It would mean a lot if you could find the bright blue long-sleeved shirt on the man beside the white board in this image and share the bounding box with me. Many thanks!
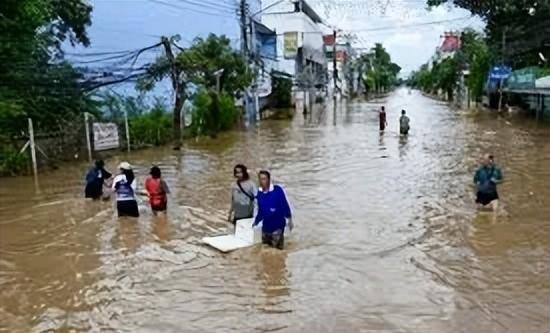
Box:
[254,185,292,234]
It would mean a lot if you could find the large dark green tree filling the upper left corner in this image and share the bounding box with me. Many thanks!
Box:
[0,0,94,137]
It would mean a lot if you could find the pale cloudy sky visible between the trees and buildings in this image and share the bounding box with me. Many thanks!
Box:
[77,0,483,80]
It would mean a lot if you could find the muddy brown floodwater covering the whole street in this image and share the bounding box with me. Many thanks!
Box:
[0,90,550,333]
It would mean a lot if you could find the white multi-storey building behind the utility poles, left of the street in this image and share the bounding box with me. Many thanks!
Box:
[262,0,327,83]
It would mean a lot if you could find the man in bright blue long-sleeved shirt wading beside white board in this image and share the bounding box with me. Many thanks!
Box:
[254,170,294,250]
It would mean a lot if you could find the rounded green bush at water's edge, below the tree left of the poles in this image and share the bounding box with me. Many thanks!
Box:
[191,89,239,137]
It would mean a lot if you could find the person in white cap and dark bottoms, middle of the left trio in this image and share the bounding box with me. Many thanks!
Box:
[113,162,139,217]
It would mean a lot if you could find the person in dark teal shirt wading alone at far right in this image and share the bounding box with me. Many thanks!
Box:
[474,155,502,211]
